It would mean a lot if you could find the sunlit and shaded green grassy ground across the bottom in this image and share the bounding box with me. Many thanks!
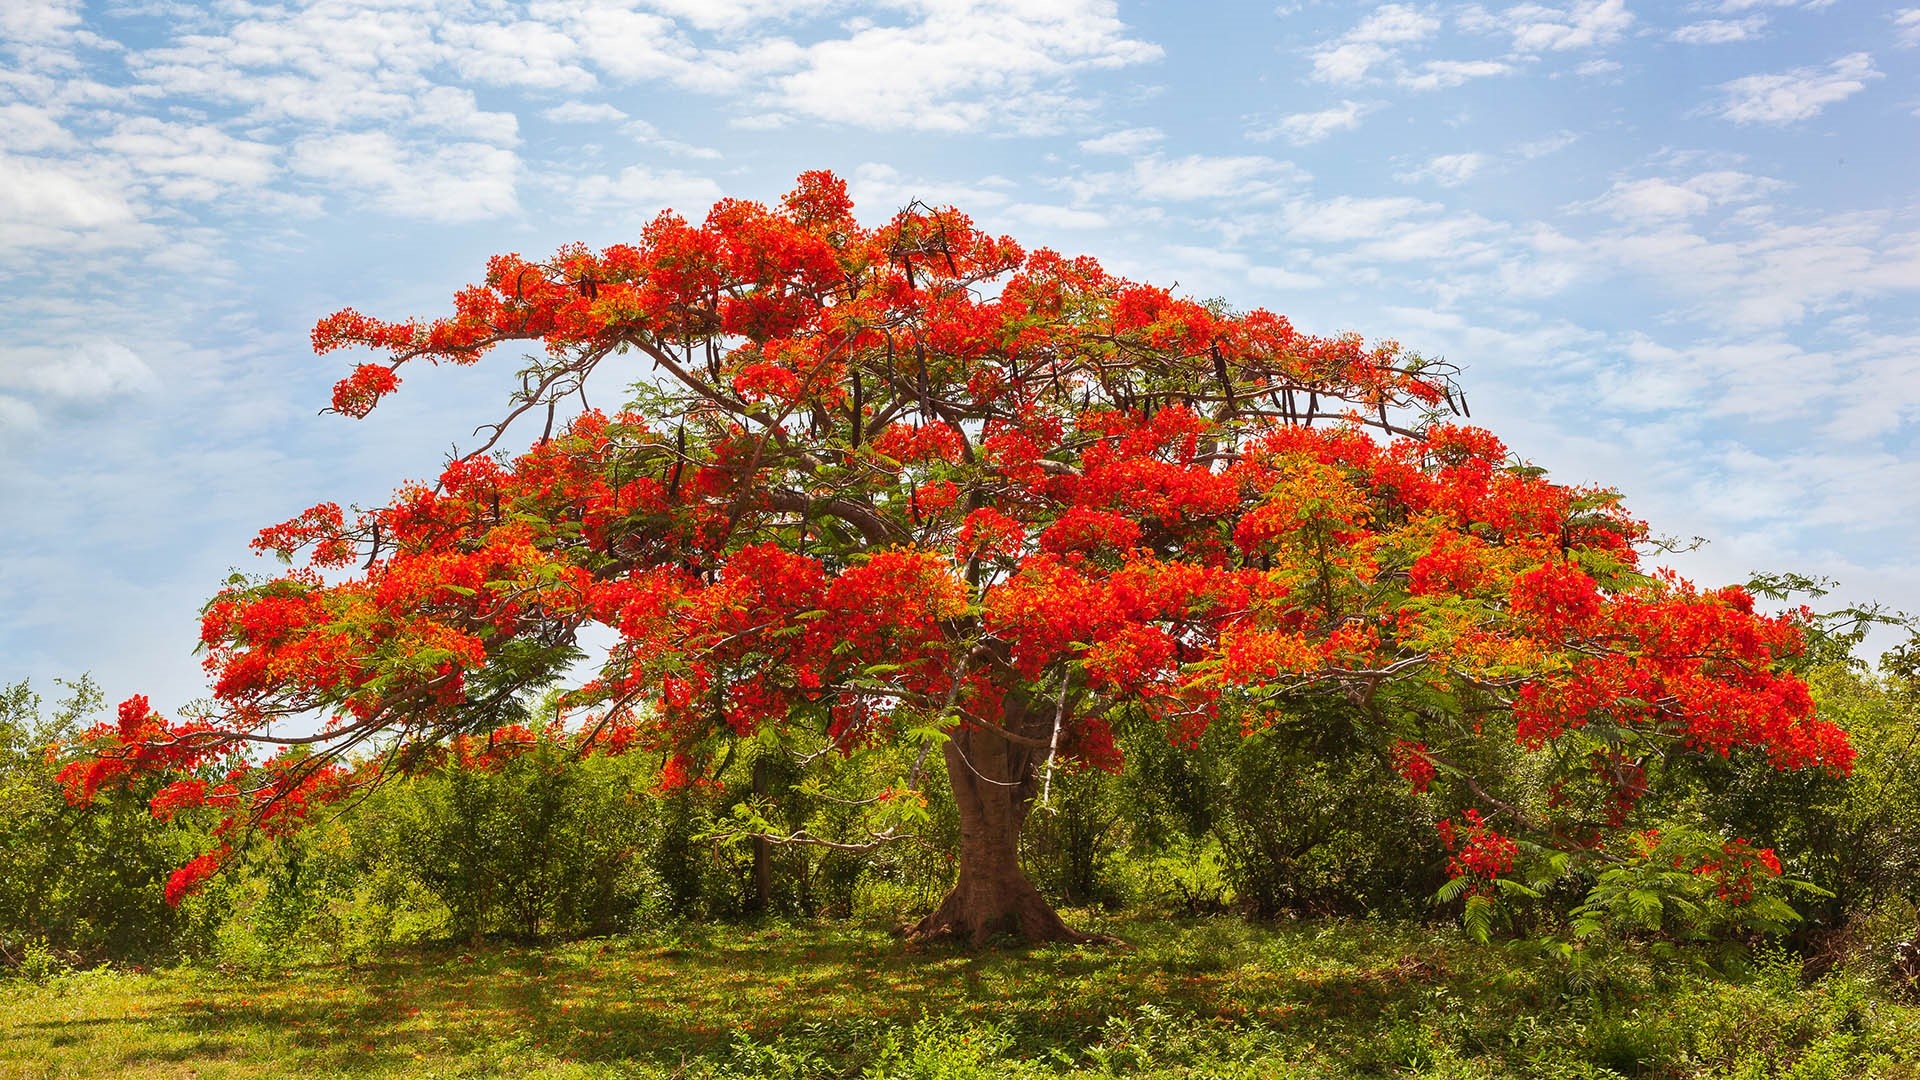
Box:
[0,913,1920,1080]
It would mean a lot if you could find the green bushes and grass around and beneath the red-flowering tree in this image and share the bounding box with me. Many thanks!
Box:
[11,622,1920,1080]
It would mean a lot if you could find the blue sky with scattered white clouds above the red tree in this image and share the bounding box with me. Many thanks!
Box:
[0,0,1920,707]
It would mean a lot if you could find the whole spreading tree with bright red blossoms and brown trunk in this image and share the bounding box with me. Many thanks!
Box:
[69,173,1849,940]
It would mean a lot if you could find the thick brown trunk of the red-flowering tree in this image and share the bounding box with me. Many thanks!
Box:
[908,701,1092,945]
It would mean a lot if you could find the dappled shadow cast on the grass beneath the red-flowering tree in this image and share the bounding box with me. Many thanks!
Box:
[15,926,1505,1076]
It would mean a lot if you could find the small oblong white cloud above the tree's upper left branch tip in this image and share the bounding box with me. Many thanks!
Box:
[288,131,520,223]
